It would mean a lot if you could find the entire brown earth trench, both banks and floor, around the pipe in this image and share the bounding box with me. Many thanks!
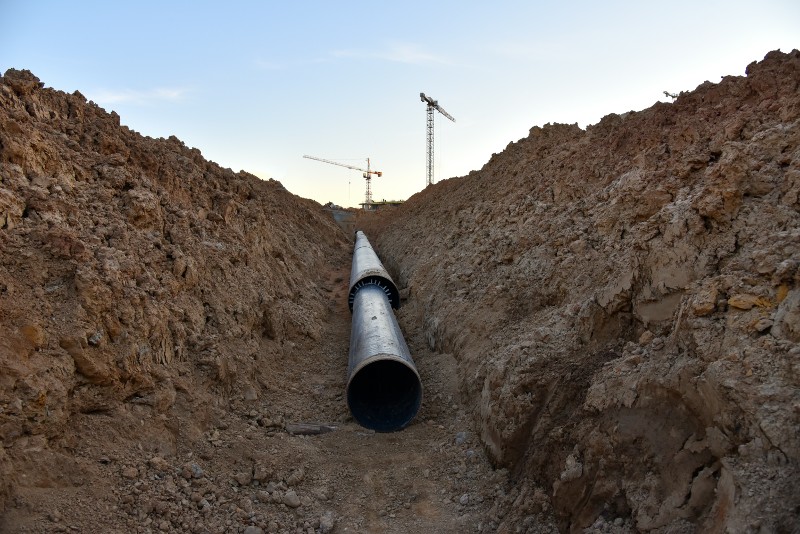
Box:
[0,51,800,534]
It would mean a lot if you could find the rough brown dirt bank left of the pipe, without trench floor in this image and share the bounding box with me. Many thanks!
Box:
[0,69,360,530]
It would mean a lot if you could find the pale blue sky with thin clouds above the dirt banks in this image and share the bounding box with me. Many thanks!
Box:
[0,0,800,206]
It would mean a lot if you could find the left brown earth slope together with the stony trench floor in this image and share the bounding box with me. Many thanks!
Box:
[0,69,509,534]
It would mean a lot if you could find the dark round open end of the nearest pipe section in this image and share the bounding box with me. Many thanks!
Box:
[347,358,422,432]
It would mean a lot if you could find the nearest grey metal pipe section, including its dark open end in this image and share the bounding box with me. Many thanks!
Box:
[347,232,422,432]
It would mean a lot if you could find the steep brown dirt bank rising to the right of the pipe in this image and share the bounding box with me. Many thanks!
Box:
[360,51,800,532]
